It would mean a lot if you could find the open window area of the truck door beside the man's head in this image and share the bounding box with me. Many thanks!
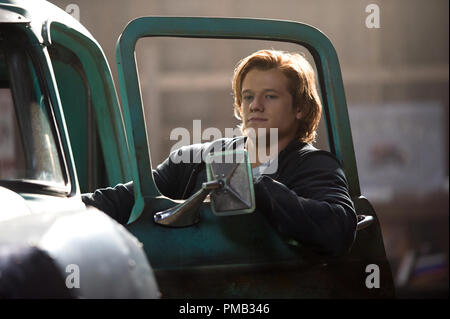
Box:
[136,37,329,169]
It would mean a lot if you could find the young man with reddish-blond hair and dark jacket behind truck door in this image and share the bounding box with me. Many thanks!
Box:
[83,50,357,256]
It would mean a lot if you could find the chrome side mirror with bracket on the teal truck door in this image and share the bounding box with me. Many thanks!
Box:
[153,150,255,227]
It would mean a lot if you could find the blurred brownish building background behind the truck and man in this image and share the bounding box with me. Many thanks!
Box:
[51,0,449,298]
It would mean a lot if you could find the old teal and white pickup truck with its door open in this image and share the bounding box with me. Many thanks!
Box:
[0,0,394,298]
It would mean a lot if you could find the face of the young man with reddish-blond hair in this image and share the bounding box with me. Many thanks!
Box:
[241,68,301,141]
